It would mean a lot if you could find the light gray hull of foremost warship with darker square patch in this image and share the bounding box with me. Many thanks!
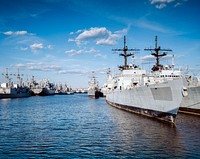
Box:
[106,78,183,123]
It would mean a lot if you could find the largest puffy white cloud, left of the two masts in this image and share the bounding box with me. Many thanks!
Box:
[68,27,127,45]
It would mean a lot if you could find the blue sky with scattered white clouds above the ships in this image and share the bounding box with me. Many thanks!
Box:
[0,0,200,88]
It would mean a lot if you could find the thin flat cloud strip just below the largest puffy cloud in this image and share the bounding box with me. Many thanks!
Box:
[65,48,99,56]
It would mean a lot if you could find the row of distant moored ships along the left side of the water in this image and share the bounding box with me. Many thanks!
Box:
[0,69,73,99]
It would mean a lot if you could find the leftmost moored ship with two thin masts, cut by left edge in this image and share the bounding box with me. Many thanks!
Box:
[0,69,31,99]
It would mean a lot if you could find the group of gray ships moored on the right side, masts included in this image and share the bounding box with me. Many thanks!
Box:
[88,36,200,124]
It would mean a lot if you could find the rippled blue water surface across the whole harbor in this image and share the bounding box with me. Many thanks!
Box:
[0,94,200,159]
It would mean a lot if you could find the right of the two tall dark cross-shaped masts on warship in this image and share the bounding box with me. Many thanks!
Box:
[144,36,172,71]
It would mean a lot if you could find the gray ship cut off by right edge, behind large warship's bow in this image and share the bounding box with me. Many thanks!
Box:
[179,76,200,115]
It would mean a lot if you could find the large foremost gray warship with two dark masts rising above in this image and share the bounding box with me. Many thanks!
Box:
[106,36,187,124]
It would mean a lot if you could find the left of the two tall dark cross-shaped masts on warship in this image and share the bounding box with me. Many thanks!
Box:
[112,36,140,70]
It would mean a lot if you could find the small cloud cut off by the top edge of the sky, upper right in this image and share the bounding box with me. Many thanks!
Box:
[150,0,186,9]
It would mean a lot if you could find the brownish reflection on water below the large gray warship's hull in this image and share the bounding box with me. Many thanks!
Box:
[105,104,185,158]
